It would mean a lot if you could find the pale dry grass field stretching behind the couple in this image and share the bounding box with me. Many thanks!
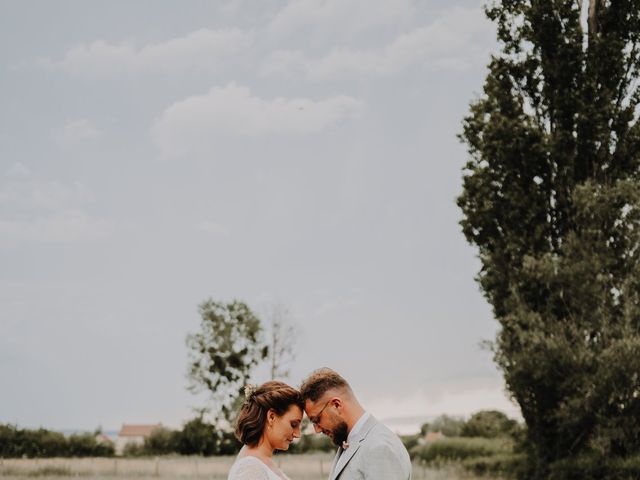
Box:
[0,454,500,480]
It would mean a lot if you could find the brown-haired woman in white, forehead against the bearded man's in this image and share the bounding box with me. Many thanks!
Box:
[228,381,304,480]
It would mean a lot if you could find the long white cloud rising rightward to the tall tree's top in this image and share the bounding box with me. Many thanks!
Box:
[261,7,493,80]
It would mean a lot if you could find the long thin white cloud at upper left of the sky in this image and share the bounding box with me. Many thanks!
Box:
[39,28,253,76]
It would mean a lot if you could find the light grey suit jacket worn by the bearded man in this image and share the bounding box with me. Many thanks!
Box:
[329,416,411,480]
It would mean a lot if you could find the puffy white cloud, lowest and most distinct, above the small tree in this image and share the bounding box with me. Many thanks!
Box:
[152,83,362,155]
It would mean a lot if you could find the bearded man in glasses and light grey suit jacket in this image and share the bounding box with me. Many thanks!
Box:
[300,368,411,480]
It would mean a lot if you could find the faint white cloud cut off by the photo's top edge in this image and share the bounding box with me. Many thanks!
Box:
[268,0,413,39]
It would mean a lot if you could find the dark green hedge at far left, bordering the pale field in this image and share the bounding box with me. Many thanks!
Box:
[0,425,114,458]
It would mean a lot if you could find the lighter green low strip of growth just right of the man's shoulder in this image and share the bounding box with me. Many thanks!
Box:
[411,437,513,465]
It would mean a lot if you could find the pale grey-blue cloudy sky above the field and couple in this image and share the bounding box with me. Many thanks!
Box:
[0,0,518,429]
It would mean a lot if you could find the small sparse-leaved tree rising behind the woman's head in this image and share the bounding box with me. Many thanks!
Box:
[187,300,268,421]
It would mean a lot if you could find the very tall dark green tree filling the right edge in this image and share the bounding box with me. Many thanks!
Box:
[458,0,640,478]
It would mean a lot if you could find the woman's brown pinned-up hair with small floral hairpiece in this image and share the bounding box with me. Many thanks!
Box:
[235,381,304,447]
